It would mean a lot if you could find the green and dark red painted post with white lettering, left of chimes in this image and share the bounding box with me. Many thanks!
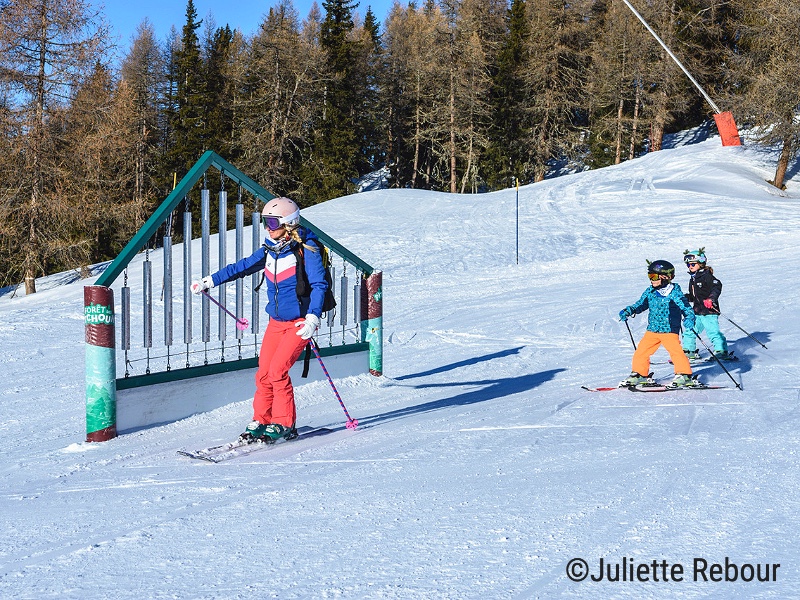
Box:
[83,285,117,442]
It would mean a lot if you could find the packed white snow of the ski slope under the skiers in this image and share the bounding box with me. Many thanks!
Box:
[0,132,800,600]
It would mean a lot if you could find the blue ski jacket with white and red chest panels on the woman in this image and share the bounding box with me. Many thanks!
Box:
[211,227,328,321]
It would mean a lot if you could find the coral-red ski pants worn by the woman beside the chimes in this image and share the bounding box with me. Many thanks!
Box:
[253,319,308,427]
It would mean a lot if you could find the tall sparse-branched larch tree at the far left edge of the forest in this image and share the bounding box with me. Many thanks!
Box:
[0,0,107,294]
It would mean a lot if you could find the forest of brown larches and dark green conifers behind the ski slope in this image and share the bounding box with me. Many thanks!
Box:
[0,0,800,293]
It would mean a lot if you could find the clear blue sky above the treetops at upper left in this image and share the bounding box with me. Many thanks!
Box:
[97,0,396,49]
